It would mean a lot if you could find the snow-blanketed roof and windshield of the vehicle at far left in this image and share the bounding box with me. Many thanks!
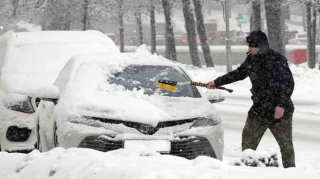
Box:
[0,30,120,96]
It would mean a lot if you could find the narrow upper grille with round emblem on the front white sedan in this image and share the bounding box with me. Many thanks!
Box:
[86,117,198,135]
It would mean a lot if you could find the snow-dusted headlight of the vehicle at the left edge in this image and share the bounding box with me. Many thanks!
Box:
[3,93,35,113]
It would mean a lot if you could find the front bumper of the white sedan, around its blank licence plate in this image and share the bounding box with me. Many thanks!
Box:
[58,119,223,160]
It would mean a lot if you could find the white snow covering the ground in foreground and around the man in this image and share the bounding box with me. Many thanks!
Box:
[0,46,320,179]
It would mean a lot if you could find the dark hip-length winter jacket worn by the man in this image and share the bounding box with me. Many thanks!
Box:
[214,47,294,122]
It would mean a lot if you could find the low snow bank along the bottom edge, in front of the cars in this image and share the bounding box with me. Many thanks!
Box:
[0,148,319,179]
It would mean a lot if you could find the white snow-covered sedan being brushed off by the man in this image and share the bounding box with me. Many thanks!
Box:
[36,47,224,160]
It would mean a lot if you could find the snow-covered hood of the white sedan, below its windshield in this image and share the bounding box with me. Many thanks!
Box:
[59,91,217,126]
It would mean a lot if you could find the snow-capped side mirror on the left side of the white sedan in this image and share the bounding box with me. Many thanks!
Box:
[36,85,60,104]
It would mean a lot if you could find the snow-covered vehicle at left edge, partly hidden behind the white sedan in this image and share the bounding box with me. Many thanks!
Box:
[0,31,120,152]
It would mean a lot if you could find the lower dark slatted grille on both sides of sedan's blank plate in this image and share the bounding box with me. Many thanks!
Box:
[78,136,216,159]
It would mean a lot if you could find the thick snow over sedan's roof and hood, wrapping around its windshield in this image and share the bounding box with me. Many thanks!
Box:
[55,46,217,126]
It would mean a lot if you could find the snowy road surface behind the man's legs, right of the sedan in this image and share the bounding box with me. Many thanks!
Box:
[219,92,320,169]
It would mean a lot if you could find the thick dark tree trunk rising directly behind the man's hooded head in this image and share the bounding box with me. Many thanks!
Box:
[265,0,285,55]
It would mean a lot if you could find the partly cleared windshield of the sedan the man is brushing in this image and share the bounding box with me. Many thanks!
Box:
[109,65,200,98]
